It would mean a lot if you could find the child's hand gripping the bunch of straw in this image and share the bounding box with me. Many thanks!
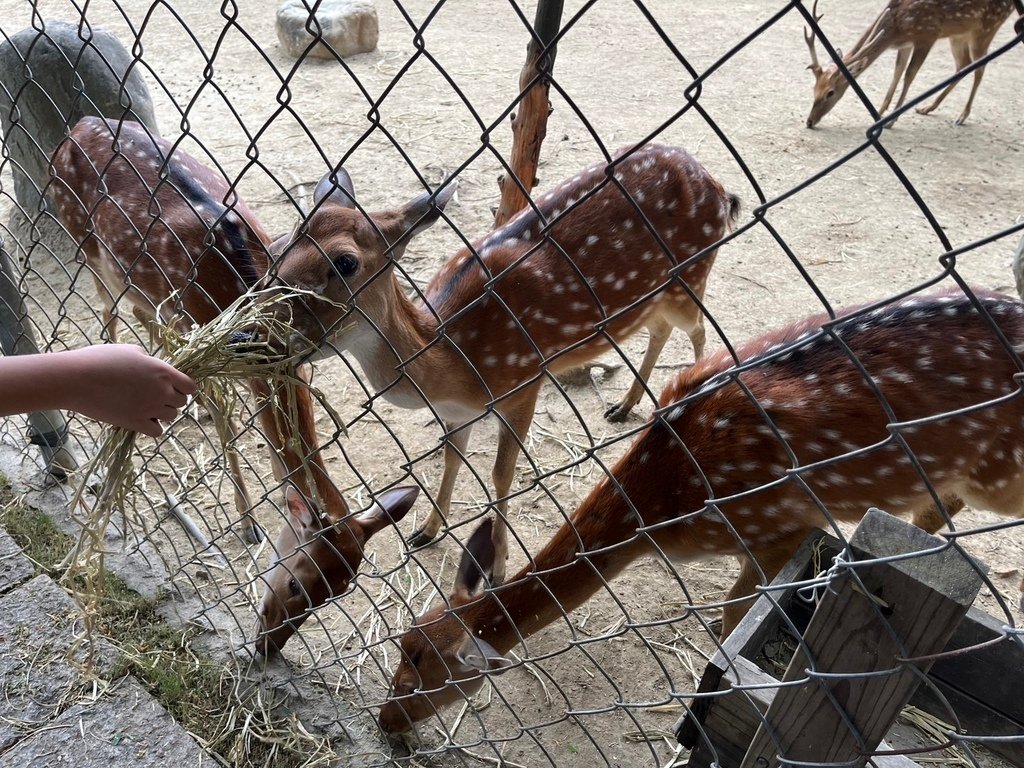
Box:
[59,344,196,437]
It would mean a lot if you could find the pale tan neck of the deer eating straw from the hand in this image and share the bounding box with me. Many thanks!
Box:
[346,278,461,408]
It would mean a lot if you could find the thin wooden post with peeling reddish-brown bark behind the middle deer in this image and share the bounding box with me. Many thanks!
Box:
[495,0,563,227]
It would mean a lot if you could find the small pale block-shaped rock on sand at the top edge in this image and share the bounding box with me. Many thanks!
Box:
[278,0,380,58]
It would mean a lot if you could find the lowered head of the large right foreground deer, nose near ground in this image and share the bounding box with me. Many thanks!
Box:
[379,519,512,733]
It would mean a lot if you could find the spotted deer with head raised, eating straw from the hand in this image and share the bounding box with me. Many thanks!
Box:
[256,144,738,582]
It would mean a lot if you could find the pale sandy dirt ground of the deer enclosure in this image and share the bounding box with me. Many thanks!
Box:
[0,0,1024,766]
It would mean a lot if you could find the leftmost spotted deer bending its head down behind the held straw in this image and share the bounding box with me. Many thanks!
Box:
[52,118,417,650]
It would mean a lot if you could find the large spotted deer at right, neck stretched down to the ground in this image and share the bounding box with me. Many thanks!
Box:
[380,292,1024,732]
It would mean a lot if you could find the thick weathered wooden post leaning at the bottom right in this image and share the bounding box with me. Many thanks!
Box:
[741,510,981,768]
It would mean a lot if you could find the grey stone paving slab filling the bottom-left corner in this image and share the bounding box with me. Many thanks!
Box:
[0,678,209,768]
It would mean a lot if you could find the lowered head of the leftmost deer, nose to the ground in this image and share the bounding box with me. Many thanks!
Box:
[256,485,420,654]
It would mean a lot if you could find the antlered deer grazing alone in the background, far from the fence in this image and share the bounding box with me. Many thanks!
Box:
[804,0,1013,128]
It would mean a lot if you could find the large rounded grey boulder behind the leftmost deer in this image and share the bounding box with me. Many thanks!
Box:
[0,20,157,218]
